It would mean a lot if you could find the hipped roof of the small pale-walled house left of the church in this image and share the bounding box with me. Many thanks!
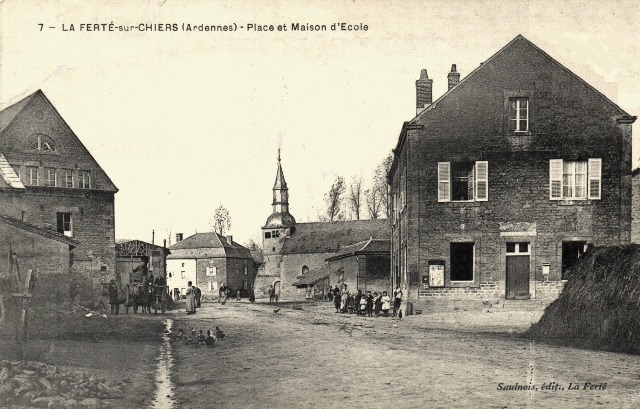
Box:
[167,232,253,259]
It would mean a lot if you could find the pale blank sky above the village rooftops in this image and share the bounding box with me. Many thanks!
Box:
[0,0,640,244]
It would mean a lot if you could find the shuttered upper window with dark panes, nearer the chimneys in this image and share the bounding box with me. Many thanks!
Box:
[438,161,489,202]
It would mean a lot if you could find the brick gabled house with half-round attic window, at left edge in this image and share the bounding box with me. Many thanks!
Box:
[0,90,118,299]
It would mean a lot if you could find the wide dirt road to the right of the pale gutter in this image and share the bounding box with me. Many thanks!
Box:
[173,303,640,408]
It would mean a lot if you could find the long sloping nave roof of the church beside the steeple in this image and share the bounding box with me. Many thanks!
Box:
[280,219,391,254]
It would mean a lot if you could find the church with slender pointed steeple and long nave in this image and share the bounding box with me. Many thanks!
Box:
[255,153,389,300]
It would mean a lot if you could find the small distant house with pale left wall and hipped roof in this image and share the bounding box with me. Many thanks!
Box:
[167,232,256,297]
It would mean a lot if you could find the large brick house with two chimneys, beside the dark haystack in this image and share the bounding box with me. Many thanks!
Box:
[389,35,636,305]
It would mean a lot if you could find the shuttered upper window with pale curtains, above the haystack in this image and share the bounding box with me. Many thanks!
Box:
[549,159,602,200]
